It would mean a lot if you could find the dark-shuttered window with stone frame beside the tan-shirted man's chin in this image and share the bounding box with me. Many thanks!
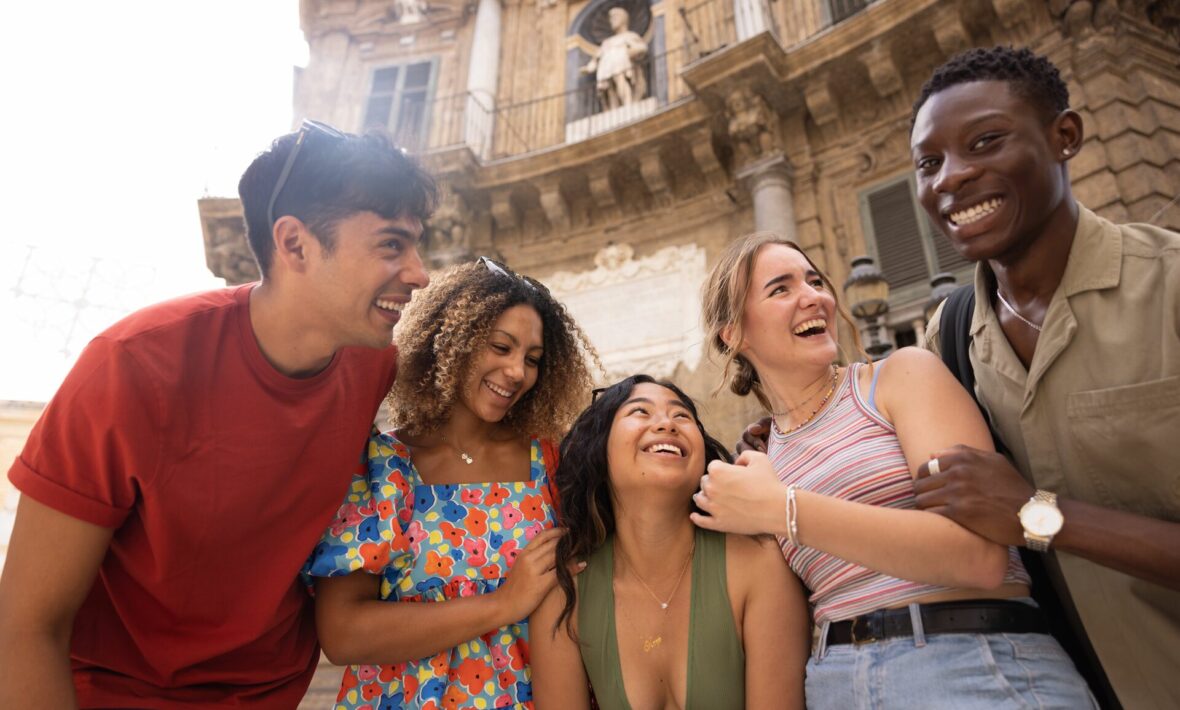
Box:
[860,175,968,294]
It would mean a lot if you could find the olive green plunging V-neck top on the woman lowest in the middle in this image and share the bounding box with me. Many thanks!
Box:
[577,528,746,710]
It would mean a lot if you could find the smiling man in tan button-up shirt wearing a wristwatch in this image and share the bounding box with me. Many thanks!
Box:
[911,47,1180,709]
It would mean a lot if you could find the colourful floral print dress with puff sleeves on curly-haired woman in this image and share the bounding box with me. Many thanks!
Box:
[307,430,556,710]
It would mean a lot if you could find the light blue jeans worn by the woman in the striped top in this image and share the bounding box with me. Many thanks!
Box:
[806,603,1099,710]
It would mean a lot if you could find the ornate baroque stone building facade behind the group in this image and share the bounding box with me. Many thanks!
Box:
[201,0,1180,440]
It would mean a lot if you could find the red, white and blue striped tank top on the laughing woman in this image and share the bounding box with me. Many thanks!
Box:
[768,362,1029,624]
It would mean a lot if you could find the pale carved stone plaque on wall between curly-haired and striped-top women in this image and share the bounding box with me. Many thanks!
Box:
[543,244,706,379]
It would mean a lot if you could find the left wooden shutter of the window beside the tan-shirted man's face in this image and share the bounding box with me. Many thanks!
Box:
[866,180,930,289]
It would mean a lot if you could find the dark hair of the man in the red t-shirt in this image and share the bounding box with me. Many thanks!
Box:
[237,131,438,277]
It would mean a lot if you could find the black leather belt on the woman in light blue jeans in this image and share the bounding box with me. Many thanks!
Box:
[827,600,1049,646]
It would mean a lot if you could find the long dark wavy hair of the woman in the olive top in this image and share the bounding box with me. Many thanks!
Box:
[553,375,732,638]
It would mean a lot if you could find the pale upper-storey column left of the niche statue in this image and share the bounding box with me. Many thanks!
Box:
[464,0,500,158]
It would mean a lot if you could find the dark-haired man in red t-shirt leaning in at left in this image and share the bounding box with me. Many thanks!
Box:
[0,121,437,708]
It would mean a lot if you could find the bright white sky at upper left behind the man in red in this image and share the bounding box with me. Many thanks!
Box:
[0,0,307,401]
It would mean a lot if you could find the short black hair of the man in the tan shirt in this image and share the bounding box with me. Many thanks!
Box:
[910,46,1069,126]
